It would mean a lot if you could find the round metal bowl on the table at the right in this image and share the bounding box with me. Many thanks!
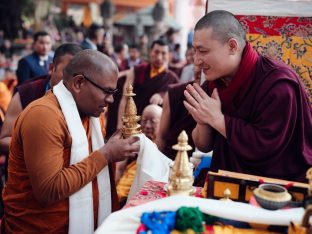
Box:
[253,184,291,210]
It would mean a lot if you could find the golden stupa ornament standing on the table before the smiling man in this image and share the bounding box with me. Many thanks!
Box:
[168,131,194,196]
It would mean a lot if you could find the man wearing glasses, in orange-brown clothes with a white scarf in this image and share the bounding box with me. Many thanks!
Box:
[4,50,139,233]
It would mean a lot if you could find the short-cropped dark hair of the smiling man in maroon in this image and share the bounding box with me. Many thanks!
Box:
[195,10,246,48]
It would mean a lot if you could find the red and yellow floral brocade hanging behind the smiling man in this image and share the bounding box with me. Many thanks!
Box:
[236,15,312,102]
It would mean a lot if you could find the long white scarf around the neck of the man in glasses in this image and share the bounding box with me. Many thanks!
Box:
[53,81,112,234]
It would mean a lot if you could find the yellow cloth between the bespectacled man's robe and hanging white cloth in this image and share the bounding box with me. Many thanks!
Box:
[117,161,137,201]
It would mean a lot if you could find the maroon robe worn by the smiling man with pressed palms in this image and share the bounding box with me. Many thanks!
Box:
[210,56,312,182]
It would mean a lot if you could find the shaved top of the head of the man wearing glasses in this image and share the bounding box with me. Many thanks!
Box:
[63,49,118,81]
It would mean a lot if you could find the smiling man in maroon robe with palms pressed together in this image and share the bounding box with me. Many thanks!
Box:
[184,11,312,182]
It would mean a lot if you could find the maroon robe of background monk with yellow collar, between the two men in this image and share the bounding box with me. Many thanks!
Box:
[133,64,178,115]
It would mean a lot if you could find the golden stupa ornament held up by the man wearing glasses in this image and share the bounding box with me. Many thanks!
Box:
[121,84,141,138]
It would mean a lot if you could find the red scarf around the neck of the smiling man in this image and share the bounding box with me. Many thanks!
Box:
[209,42,259,113]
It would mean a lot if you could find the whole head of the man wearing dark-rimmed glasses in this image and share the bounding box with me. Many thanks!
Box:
[63,50,118,117]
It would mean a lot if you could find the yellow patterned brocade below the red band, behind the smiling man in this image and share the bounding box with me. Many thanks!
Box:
[247,34,312,102]
